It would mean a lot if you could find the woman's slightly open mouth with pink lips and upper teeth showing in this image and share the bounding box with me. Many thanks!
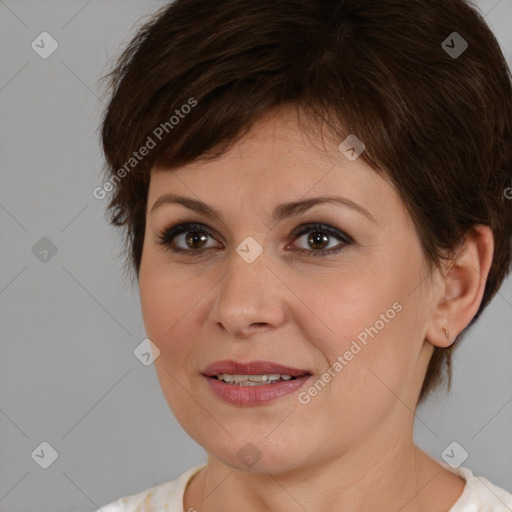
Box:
[201,360,312,405]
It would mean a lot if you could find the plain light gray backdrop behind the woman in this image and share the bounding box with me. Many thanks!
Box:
[0,0,512,512]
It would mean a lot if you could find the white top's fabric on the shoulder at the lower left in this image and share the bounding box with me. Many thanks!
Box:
[96,464,205,512]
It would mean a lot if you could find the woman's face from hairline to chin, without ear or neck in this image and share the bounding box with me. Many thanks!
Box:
[139,108,433,472]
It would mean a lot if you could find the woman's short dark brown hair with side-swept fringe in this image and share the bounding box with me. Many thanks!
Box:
[101,0,512,402]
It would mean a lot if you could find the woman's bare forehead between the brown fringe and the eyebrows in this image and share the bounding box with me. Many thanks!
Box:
[148,107,397,222]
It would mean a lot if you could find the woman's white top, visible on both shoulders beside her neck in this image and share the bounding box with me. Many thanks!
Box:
[96,461,512,512]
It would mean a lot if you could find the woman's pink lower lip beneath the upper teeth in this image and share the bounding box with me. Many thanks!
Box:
[204,375,311,405]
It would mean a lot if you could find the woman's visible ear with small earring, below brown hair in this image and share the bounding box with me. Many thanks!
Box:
[426,224,494,347]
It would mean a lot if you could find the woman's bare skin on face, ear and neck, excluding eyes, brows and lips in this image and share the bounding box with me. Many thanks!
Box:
[139,108,493,512]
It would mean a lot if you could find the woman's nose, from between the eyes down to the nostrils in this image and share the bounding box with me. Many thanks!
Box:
[210,246,287,338]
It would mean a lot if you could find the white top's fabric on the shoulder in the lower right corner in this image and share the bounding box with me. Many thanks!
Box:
[442,467,512,512]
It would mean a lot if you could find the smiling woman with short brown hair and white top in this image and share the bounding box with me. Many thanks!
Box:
[94,0,512,512]
